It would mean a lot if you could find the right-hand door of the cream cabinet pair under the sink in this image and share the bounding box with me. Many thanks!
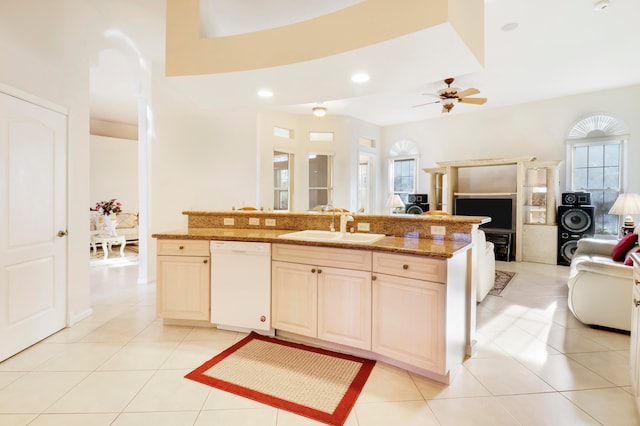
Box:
[318,267,371,350]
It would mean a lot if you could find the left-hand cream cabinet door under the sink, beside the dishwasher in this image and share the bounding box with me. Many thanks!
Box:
[271,261,318,337]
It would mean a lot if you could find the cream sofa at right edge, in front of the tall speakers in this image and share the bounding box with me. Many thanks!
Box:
[567,235,638,331]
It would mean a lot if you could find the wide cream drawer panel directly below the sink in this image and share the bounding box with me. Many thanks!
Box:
[271,244,371,271]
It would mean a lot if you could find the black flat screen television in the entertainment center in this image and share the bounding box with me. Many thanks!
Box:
[454,197,515,231]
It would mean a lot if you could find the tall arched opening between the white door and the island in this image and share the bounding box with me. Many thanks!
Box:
[90,38,150,283]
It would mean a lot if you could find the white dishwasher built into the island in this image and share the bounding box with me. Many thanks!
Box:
[211,241,272,334]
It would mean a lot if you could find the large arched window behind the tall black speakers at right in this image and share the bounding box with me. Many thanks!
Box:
[567,114,629,235]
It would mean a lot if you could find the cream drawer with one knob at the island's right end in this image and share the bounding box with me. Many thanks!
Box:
[373,252,447,283]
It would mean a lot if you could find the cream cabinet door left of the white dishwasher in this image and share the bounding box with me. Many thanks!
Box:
[156,256,211,321]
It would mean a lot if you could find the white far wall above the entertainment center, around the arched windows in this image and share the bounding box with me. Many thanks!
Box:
[383,86,640,198]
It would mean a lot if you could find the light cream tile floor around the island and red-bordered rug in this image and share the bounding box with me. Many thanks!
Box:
[0,262,640,426]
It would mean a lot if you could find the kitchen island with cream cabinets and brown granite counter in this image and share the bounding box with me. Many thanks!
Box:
[153,212,486,383]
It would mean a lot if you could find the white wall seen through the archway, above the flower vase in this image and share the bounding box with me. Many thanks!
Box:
[90,135,138,213]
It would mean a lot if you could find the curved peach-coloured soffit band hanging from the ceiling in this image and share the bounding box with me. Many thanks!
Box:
[166,0,484,76]
